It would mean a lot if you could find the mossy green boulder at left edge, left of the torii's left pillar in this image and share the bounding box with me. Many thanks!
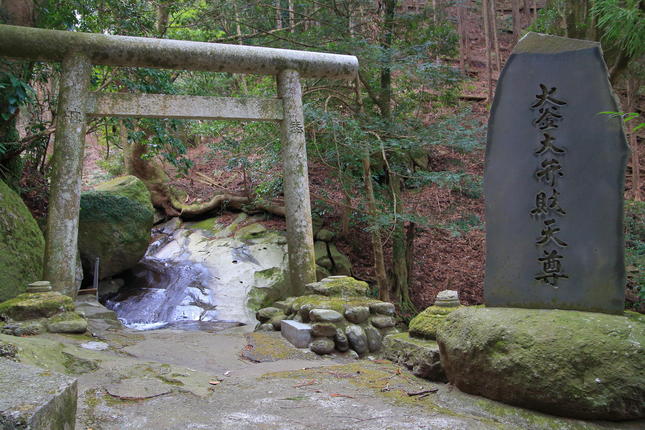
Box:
[0,181,45,301]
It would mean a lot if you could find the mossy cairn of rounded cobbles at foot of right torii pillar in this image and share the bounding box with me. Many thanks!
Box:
[256,276,398,356]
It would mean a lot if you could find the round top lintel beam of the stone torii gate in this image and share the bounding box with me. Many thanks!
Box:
[0,25,358,79]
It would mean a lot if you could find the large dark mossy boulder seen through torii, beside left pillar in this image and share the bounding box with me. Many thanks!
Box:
[78,176,154,279]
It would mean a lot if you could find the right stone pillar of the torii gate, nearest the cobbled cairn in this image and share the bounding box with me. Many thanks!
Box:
[278,70,316,295]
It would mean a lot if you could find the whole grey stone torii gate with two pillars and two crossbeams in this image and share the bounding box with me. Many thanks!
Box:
[0,25,358,296]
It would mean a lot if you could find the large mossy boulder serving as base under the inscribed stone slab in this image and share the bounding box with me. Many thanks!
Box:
[437,308,645,420]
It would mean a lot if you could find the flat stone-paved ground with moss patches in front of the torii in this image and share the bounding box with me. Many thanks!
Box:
[0,303,644,430]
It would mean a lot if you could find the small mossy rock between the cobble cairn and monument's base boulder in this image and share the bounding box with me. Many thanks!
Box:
[383,333,447,382]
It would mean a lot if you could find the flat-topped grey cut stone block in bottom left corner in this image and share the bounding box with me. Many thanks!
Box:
[0,358,77,430]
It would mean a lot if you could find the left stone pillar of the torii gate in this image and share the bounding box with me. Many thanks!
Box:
[43,53,92,297]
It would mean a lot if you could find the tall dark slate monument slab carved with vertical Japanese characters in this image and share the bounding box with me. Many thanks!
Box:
[484,33,628,313]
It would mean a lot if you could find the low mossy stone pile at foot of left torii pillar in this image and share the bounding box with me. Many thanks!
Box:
[0,281,87,336]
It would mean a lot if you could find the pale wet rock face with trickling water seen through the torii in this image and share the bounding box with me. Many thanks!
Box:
[112,218,288,326]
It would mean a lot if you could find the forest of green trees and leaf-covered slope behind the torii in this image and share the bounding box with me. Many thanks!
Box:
[0,0,645,316]
